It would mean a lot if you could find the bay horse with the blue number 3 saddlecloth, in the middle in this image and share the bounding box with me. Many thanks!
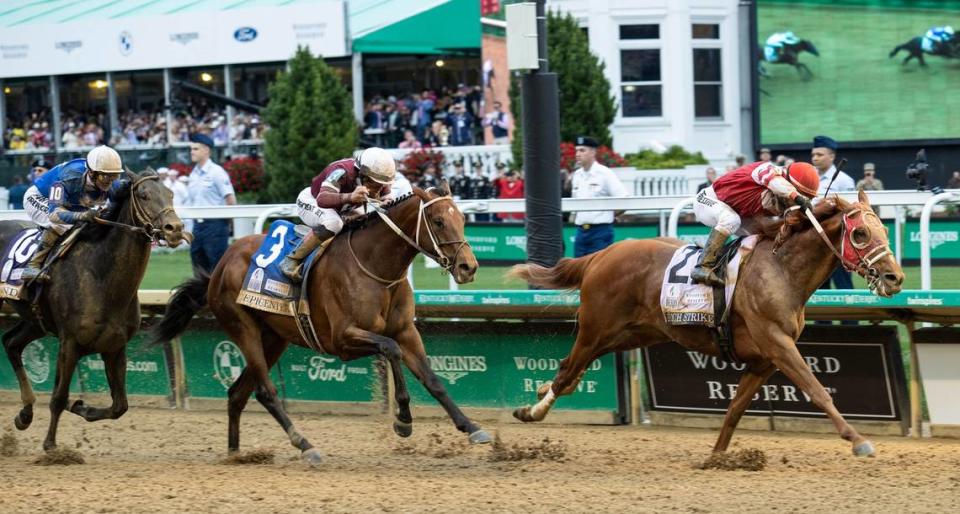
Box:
[152,183,491,465]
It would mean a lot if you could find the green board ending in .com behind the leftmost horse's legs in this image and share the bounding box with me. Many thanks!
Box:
[76,334,170,396]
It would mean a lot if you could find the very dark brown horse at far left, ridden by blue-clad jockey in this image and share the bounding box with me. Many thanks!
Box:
[0,170,184,450]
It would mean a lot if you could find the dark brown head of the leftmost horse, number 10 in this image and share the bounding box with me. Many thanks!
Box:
[128,169,189,248]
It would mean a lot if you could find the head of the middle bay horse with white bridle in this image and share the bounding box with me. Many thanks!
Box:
[417,181,479,284]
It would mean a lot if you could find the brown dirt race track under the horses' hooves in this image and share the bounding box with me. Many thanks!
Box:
[0,404,960,513]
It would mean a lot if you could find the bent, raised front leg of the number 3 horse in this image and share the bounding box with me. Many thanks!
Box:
[337,326,413,437]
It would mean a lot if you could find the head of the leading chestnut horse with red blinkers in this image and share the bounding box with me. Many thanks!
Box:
[838,191,903,297]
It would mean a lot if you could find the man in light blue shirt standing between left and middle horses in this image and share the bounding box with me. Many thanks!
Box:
[186,133,237,273]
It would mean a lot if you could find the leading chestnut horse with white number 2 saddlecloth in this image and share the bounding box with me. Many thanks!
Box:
[511,191,903,455]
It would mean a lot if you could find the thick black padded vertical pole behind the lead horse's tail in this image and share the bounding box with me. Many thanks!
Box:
[521,0,563,266]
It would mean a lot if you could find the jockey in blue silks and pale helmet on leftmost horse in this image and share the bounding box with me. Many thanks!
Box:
[22,146,130,281]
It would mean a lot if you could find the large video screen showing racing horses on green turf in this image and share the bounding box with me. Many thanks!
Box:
[756,0,960,145]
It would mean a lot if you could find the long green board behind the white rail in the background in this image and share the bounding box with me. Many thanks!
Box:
[466,219,960,262]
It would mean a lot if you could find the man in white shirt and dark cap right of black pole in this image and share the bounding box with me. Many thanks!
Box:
[572,136,627,257]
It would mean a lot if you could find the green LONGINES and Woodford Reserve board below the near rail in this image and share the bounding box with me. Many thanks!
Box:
[406,322,618,412]
